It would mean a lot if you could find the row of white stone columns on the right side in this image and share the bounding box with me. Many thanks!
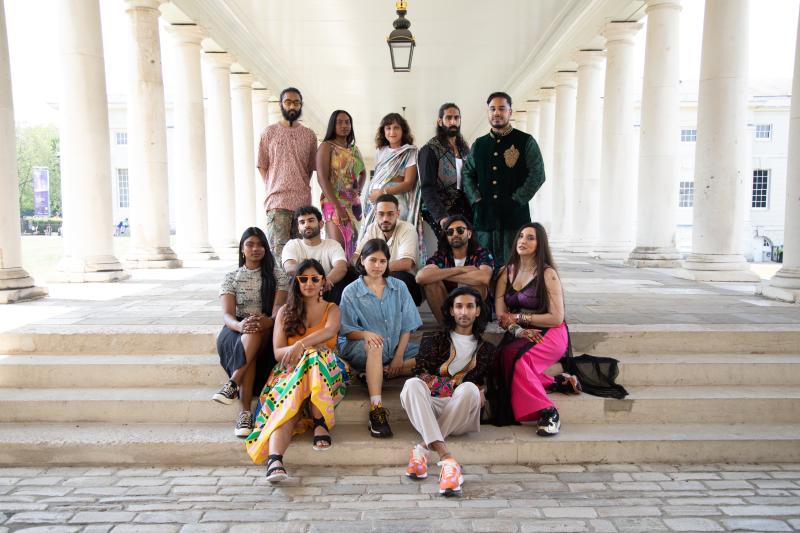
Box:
[528,0,800,290]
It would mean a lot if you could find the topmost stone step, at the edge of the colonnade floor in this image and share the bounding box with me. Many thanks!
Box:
[6,324,800,356]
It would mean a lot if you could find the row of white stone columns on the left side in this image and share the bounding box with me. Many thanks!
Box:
[0,0,280,303]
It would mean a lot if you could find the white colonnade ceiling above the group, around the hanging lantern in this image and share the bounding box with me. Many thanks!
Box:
[167,0,643,158]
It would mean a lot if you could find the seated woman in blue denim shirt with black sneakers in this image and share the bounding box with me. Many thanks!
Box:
[339,239,422,437]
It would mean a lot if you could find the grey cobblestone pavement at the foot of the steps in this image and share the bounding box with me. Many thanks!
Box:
[0,462,800,533]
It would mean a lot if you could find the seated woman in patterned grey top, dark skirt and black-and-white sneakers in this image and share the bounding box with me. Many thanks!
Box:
[212,227,289,438]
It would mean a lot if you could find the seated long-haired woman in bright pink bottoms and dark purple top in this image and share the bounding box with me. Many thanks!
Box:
[491,222,580,437]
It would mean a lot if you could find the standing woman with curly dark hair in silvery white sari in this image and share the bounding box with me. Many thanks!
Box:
[362,113,421,228]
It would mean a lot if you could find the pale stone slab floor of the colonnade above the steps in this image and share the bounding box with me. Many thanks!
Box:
[0,254,800,332]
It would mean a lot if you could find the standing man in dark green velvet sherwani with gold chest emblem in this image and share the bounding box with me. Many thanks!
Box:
[462,92,544,268]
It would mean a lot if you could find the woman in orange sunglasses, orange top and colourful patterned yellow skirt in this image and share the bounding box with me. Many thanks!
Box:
[246,259,347,483]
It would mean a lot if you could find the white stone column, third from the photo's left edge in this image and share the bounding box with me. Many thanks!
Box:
[125,0,182,268]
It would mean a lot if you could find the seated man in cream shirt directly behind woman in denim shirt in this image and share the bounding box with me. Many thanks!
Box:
[351,194,422,307]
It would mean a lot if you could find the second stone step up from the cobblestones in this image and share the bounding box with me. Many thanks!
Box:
[0,380,800,424]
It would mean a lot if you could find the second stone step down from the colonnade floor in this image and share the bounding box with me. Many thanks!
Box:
[0,354,800,388]
